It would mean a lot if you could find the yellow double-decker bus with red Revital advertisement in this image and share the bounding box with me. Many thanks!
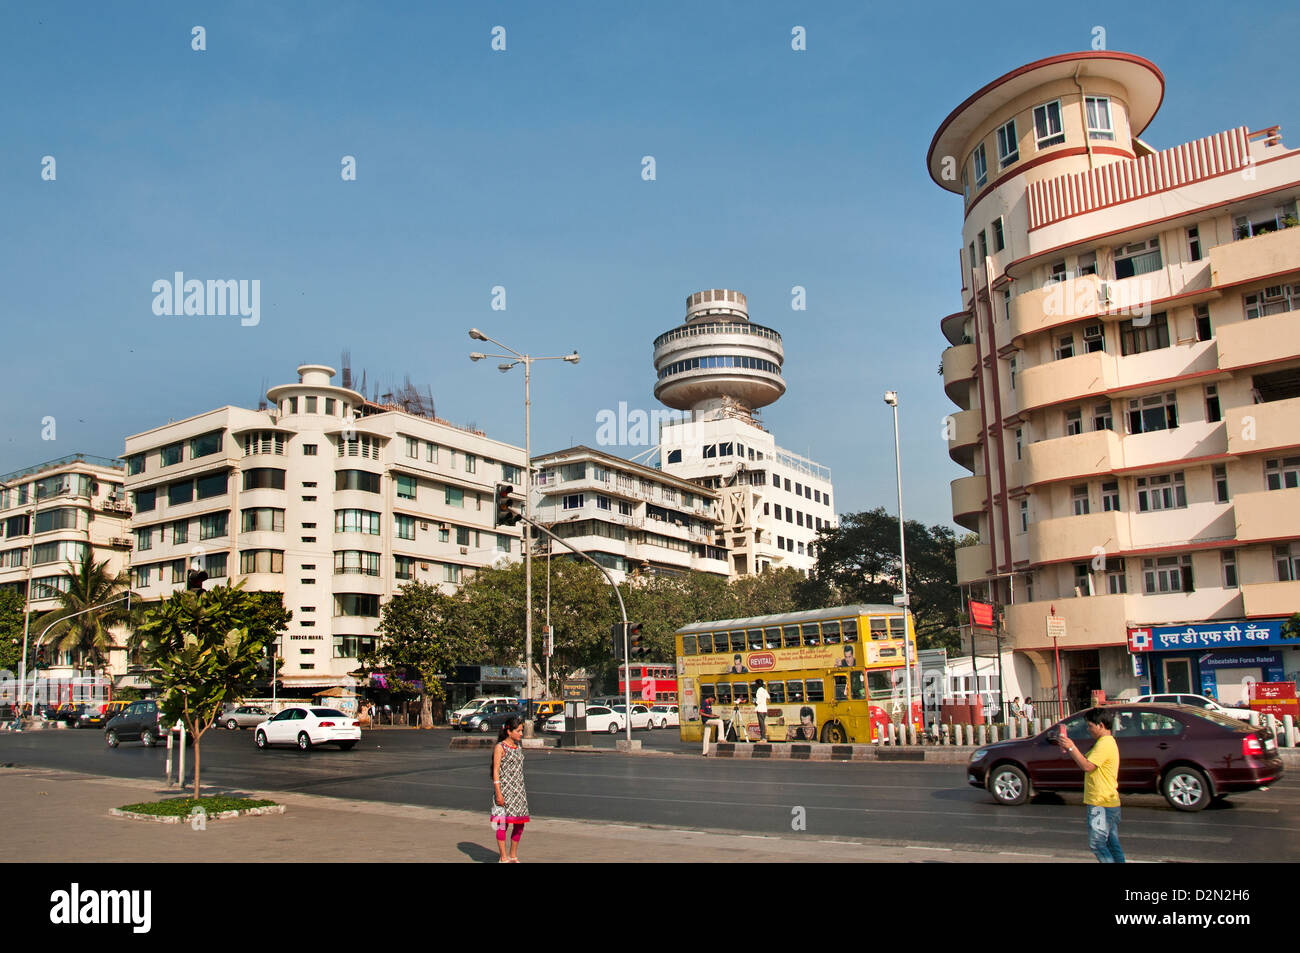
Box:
[675,605,920,744]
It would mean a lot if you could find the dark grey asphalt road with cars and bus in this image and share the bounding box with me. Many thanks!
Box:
[0,729,1300,862]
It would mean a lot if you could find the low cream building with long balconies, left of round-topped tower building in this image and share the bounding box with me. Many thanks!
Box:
[532,447,729,582]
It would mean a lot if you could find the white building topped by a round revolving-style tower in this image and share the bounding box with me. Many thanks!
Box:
[654,289,836,576]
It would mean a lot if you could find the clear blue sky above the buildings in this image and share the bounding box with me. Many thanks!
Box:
[0,1,1300,524]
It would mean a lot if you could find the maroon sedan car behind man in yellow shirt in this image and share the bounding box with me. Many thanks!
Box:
[966,705,1282,811]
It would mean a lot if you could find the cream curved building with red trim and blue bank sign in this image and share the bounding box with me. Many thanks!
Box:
[928,52,1300,705]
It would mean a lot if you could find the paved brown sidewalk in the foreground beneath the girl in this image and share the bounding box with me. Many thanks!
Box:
[0,767,1093,863]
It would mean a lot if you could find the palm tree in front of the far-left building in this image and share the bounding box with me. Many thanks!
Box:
[38,546,133,675]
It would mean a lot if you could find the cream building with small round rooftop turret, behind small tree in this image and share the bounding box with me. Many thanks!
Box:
[124,364,524,693]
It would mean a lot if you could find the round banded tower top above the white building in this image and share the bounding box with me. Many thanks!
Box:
[654,289,785,412]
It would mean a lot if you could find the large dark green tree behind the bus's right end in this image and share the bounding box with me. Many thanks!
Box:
[803,507,962,650]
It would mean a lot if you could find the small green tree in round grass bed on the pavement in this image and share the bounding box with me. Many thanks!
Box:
[138,581,293,798]
